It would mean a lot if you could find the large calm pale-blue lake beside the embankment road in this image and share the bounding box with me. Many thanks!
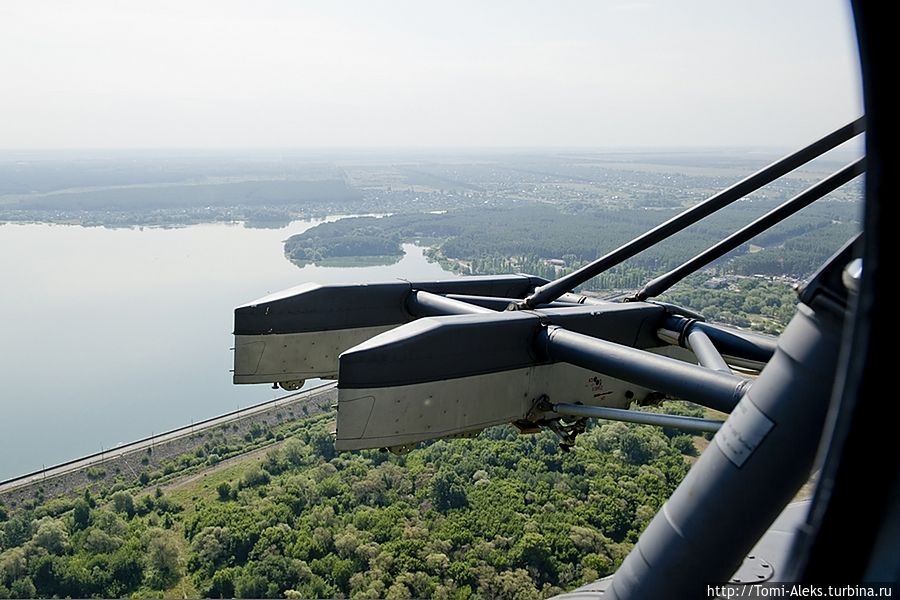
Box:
[0,221,453,480]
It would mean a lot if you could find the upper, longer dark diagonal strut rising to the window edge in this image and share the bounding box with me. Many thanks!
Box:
[524,117,865,308]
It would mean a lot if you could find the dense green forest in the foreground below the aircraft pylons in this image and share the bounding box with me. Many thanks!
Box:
[0,403,697,599]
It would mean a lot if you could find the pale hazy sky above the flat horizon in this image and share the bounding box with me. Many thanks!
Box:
[0,0,862,149]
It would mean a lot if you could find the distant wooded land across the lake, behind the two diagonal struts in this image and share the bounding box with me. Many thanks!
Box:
[285,201,859,334]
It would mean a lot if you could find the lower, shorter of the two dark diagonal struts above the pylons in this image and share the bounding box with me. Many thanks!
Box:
[632,158,866,300]
